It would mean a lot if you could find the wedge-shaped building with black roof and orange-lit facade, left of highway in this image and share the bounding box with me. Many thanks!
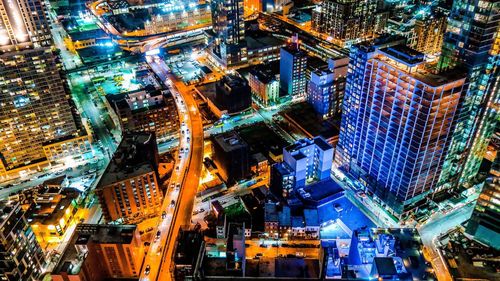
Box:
[96,133,163,223]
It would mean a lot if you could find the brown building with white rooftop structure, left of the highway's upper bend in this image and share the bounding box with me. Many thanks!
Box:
[106,86,179,138]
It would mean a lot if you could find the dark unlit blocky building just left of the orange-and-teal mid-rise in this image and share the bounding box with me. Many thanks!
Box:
[215,75,252,114]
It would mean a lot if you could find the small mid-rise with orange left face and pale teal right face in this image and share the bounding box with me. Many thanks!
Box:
[248,67,280,107]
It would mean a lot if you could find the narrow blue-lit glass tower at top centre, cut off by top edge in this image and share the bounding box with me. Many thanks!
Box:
[211,0,248,68]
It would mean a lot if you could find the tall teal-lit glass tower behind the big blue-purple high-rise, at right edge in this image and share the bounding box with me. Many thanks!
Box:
[439,0,500,188]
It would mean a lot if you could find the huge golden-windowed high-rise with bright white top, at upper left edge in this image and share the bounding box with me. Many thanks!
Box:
[0,0,77,174]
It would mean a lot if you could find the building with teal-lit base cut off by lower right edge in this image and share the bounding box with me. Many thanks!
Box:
[466,156,500,250]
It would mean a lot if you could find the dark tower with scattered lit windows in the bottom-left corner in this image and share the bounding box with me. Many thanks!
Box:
[0,202,44,281]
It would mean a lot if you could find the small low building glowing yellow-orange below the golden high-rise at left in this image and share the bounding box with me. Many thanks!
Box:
[27,189,79,248]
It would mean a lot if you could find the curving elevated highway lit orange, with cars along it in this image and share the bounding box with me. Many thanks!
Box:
[139,57,203,280]
